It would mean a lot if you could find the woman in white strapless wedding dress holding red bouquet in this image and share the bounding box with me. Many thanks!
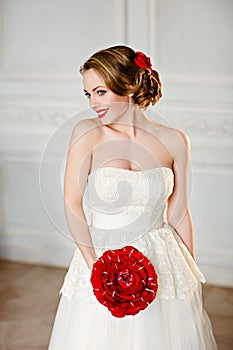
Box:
[49,46,217,350]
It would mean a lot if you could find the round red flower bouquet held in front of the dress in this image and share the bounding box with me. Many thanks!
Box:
[91,246,158,317]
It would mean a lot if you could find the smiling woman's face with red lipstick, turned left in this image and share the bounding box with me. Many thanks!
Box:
[83,68,129,124]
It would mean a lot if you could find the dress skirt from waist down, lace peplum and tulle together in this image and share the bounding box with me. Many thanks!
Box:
[48,224,217,350]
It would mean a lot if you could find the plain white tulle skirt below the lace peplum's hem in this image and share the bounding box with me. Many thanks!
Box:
[49,285,217,350]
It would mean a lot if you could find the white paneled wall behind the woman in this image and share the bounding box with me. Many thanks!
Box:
[0,0,233,286]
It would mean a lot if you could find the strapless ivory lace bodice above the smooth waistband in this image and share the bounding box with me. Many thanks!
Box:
[85,167,174,215]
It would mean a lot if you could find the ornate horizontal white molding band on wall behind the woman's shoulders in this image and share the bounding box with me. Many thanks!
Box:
[0,100,233,138]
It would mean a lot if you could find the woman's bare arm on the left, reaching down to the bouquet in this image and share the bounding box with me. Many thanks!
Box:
[64,120,97,269]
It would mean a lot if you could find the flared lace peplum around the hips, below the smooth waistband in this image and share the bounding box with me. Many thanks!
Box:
[60,223,205,302]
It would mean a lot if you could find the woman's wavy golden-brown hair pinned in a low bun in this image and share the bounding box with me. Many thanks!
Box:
[80,45,162,109]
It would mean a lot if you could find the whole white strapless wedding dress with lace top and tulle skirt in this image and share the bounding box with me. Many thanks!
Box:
[48,167,217,350]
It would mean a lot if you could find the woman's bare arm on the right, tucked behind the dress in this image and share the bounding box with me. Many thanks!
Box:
[167,129,194,258]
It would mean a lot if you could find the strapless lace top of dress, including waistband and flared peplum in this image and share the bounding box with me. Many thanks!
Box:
[60,167,205,302]
